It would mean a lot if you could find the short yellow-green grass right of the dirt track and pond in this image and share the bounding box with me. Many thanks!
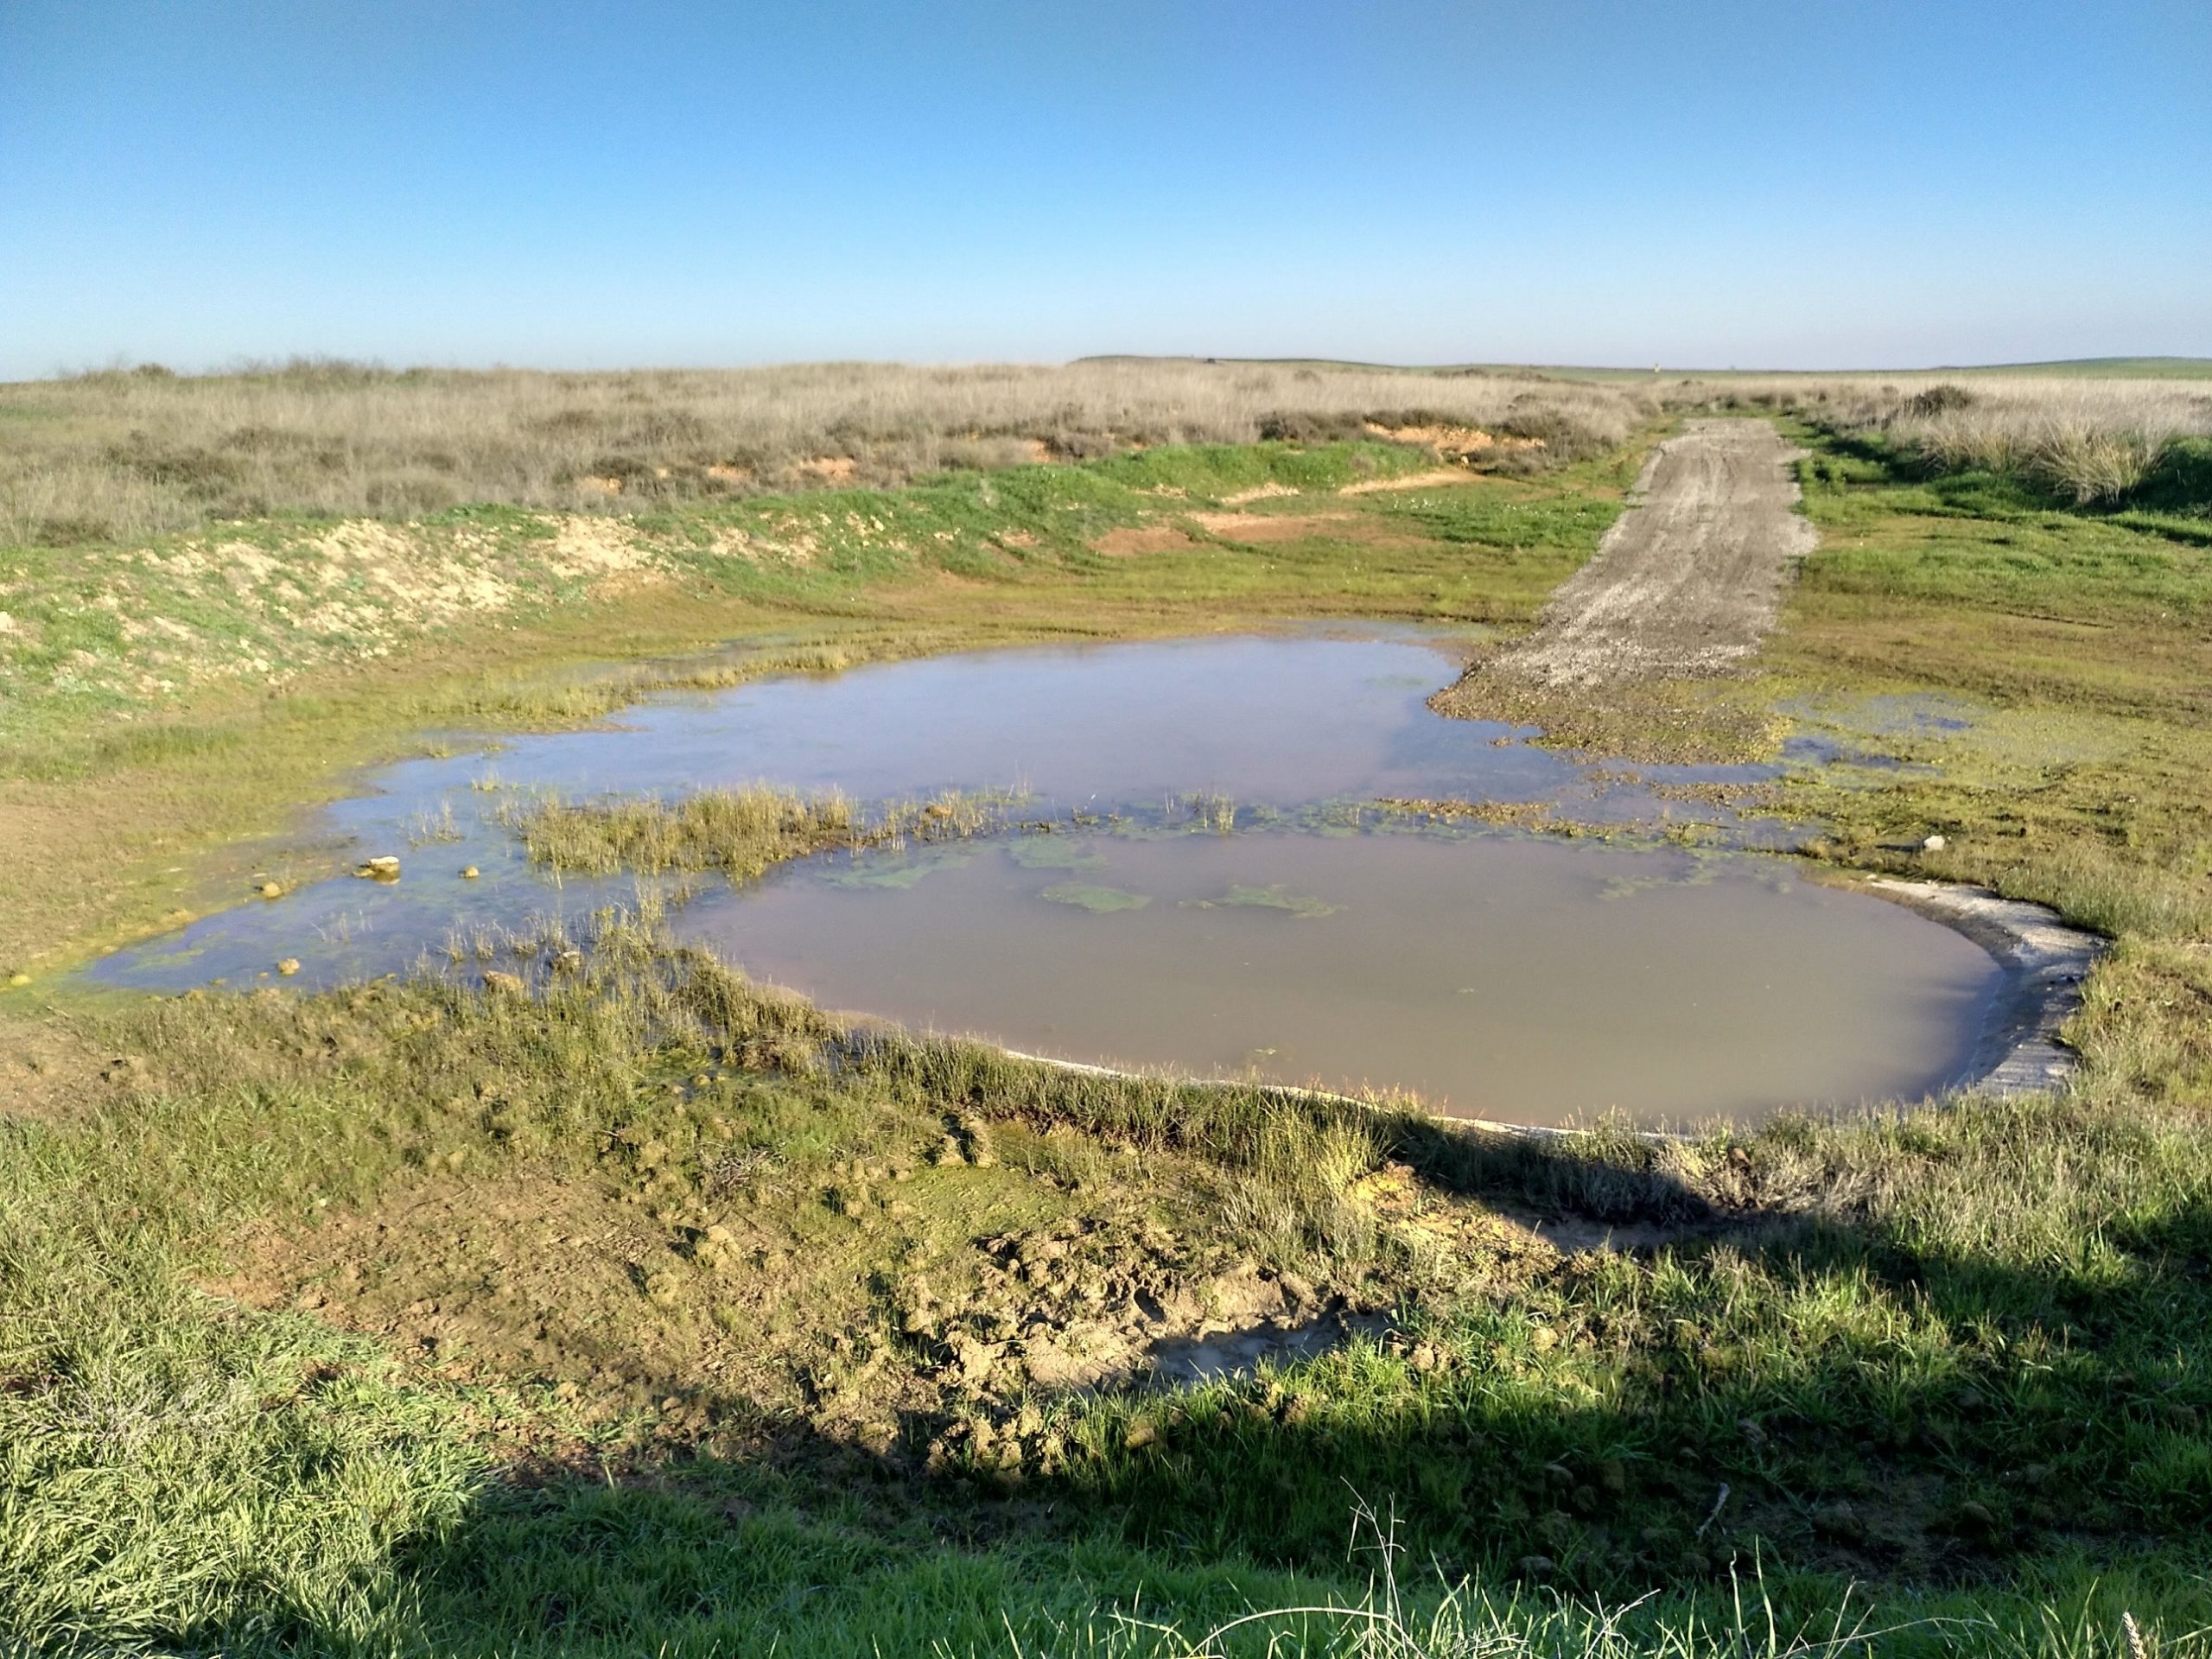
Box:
[1763,422,2212,940]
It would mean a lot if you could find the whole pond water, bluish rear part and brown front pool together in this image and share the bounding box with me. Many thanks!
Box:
[88,631,1999,1123]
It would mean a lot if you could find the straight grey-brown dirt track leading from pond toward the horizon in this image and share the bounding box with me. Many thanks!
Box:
[1478,420,1814,690]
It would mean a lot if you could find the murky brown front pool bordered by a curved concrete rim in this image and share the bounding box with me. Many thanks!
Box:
[681,832,1995,1123]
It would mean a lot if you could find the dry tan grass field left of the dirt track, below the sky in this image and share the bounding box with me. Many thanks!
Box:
[0,359,1650,546]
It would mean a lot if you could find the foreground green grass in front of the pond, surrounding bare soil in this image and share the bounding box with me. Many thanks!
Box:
[0,931,2212,1652]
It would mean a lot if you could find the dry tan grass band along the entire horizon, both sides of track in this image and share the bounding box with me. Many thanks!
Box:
[0,359,2212,559]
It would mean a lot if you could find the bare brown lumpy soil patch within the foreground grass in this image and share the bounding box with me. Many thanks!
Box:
[199,1141,1387,1451]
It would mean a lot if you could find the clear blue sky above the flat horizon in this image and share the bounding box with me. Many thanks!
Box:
[0,0,2212,378]
